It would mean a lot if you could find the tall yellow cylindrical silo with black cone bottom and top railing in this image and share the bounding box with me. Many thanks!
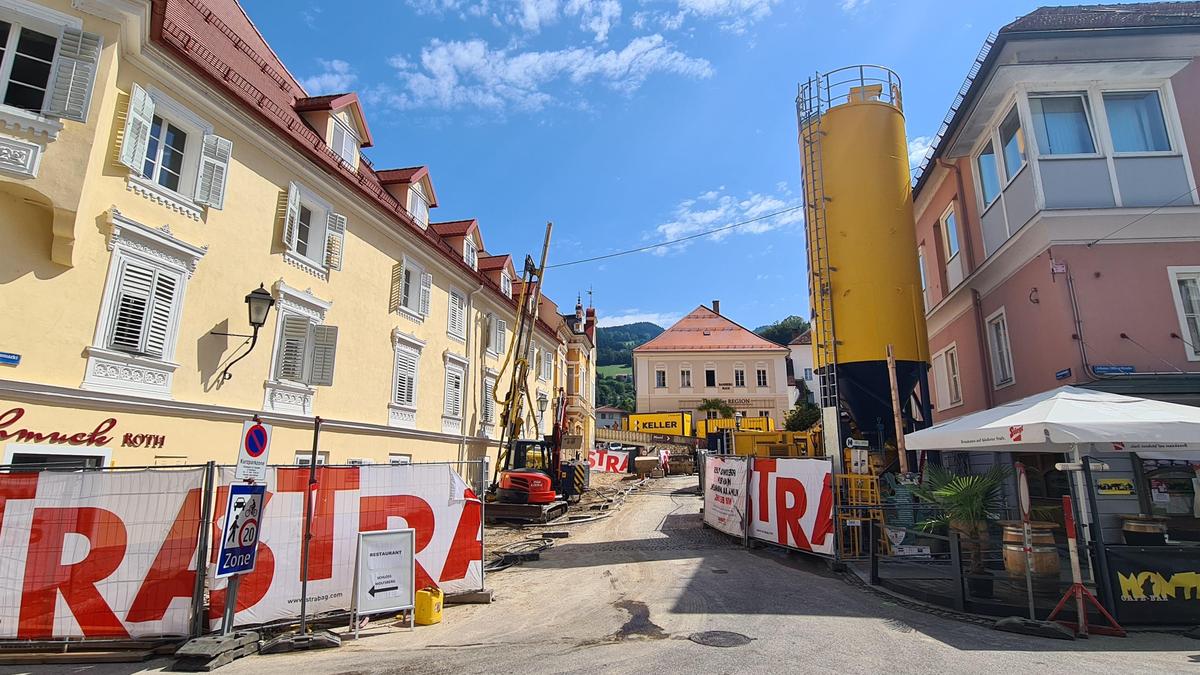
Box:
[797,66,929,437]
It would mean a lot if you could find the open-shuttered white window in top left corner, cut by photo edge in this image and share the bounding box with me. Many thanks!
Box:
[0,8,103,123]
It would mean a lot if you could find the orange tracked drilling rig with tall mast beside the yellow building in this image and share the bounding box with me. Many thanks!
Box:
[485,223,588,522]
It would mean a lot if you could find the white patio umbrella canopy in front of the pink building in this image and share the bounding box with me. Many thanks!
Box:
[905,387,1200,460]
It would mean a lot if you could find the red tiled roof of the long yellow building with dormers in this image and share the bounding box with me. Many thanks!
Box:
[150,0,556,335]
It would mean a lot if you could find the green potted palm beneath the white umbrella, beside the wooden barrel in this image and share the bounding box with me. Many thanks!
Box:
[912,465,1010,598]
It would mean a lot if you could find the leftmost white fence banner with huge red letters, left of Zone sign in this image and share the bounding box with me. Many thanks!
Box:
[0,468,204,640]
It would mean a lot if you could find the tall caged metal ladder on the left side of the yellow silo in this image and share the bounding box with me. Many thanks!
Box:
[796,74,838,407]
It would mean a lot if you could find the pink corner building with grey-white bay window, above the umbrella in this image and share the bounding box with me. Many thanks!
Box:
[913,4,1200,420]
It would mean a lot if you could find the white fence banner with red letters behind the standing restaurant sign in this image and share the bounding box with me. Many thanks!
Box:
[209,464,484,629]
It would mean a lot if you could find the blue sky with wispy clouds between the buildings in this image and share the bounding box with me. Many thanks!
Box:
[242,0,1038,327]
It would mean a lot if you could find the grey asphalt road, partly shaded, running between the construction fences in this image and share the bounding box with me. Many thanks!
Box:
[23,478,1200,675]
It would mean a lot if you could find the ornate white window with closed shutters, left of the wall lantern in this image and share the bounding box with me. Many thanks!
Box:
[83,211,204,395]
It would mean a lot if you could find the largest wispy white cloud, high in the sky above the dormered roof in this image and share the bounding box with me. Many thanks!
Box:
[371,35,713,110]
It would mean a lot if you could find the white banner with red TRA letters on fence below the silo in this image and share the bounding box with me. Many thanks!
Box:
[748,458,834,555]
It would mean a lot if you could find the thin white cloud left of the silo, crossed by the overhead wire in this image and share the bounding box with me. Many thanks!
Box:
[647,186,804,256]
